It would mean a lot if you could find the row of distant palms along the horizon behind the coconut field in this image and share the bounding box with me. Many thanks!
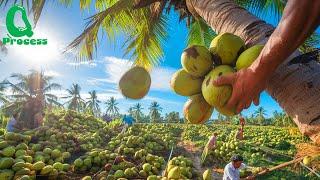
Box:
[0,70,295,127]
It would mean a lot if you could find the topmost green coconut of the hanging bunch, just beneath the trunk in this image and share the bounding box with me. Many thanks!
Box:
[209,33,245,65]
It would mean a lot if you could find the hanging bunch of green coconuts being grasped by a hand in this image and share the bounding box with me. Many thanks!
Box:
[170,33,263,124]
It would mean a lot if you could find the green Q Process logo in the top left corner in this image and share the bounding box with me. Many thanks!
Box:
[2,5,48,45]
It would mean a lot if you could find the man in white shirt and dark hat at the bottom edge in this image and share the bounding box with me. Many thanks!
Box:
[223,155,254,180]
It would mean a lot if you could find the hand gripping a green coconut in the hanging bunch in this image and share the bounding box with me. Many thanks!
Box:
[213,67,268,113]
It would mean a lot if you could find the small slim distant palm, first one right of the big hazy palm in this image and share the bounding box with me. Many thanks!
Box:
[63,84,85,112]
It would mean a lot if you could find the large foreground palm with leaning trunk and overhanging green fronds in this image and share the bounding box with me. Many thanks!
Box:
[4,0,320,143]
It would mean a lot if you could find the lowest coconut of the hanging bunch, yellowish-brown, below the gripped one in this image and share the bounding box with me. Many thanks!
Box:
[183,93,213,124]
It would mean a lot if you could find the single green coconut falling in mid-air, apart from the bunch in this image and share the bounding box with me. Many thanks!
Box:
[119,66,151,99]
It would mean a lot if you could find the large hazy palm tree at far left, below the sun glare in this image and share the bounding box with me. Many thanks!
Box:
[1,70,61,128]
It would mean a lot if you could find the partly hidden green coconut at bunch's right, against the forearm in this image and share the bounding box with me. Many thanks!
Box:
[236,45,264,70]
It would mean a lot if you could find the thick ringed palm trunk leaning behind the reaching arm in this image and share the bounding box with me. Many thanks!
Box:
[187,0,320,144]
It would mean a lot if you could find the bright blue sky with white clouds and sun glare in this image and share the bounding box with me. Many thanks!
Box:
[0,3,282,117]
